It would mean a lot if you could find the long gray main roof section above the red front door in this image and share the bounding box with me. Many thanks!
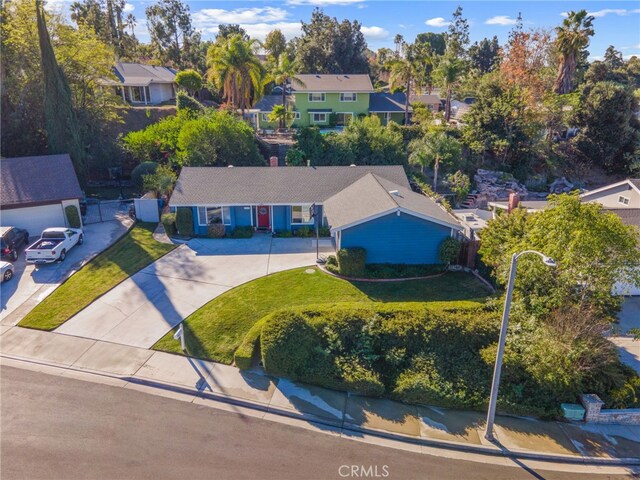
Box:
[170,165,410,206]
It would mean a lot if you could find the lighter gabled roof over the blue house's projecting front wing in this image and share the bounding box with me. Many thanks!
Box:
[324,173,461,229]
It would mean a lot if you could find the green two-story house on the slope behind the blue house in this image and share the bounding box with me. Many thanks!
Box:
[249,74,404,130]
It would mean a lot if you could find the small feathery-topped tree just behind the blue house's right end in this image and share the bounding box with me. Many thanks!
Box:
[409,131,462,192]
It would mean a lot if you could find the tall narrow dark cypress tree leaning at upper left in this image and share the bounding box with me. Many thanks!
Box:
[36,0,86,185]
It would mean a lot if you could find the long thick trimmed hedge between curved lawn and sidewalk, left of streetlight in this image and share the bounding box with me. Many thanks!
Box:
[260,304,498,409]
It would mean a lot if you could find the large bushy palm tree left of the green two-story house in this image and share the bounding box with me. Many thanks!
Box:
[207,34,264,118]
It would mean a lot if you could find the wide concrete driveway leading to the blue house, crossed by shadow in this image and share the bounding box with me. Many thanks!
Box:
[56,235,334,348]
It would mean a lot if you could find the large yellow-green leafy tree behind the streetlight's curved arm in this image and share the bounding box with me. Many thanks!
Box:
[480,193,640,318]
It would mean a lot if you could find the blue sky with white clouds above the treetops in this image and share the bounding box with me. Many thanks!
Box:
[51,0,640,59]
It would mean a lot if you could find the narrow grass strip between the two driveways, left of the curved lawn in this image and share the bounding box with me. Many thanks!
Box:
[18,223,175,330]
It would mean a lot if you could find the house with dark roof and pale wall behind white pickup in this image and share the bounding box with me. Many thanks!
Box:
[0,154,83,235]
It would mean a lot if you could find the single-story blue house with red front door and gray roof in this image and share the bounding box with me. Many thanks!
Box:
[170,165,462,263]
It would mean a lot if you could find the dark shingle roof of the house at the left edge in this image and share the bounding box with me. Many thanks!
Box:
[0,153,82,208]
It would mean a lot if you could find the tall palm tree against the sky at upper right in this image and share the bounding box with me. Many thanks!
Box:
[554,10,594,94]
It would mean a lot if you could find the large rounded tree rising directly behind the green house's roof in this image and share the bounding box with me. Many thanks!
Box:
[295,8,369,74]
